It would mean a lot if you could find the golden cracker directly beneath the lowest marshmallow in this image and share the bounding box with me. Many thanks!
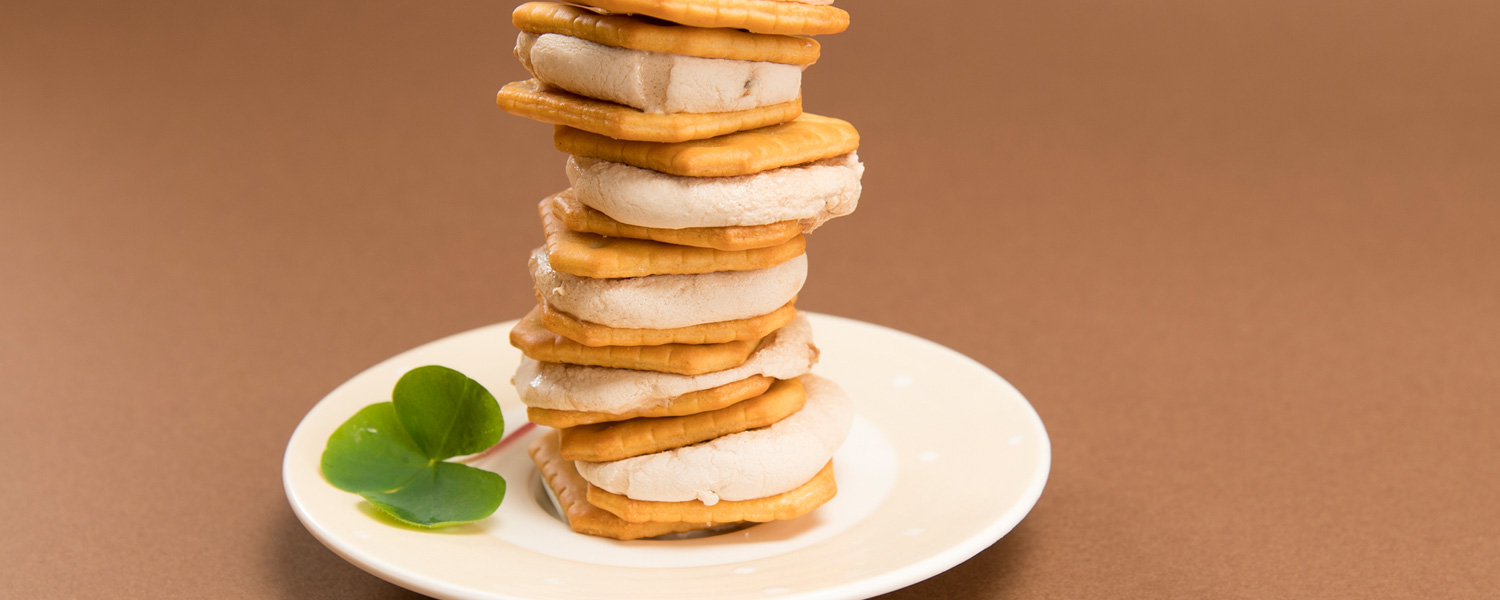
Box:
[588,461,839,524]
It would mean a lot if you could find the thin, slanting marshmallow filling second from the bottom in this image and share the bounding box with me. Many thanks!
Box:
[510,315,818,414]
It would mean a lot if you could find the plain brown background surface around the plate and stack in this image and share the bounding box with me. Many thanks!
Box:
[0,0,1500,599]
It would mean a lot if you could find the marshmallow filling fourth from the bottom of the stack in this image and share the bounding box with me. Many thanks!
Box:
[567,152,864,233]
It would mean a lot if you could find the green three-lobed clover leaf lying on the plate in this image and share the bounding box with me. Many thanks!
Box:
[321,366,506,528]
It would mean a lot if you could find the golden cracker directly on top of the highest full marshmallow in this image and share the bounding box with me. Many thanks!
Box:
[510,2,819,65]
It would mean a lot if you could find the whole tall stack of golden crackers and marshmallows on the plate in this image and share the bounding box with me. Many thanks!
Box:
[498,0,864,540]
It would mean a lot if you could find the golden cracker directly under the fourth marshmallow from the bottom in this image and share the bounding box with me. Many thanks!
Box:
[552,189,803,251]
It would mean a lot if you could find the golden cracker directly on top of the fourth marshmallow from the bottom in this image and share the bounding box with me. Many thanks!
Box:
[555,113,860,177]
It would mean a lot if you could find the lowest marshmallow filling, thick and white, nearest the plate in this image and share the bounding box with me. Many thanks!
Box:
[576,375,854,506]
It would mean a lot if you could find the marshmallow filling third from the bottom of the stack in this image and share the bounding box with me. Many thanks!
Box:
[531,248,807,329]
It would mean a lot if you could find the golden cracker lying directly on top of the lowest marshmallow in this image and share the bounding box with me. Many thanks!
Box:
[558,380,807,462]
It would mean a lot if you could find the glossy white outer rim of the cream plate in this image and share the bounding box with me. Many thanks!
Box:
[282,311,1052,600]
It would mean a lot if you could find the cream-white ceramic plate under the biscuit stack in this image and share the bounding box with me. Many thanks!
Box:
[282,314,1052,600]
